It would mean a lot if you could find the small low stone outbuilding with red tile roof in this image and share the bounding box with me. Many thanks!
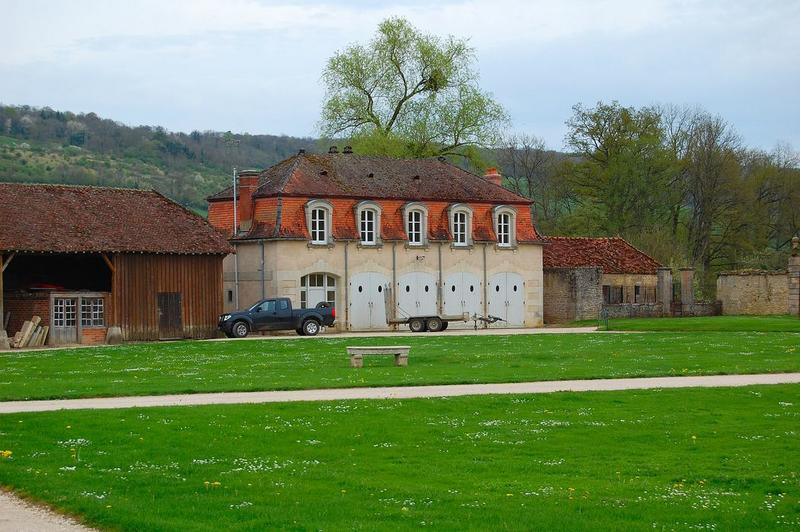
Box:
[543,237,671,323]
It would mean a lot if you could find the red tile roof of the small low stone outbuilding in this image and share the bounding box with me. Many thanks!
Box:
[543,236,661,275]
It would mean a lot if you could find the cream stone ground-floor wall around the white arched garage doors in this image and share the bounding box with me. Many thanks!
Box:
[223,240,544,330]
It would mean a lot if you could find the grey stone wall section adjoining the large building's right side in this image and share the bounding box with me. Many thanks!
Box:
[544,268,603,323]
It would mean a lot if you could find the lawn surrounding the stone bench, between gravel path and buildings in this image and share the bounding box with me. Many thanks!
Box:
[0,332,800,400]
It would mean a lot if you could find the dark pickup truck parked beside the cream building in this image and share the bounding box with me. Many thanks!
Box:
[219,297,336,338]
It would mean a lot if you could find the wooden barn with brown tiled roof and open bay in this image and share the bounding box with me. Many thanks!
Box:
[0,183,232,345]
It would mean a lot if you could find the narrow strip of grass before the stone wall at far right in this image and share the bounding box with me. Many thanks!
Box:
[604,316,800,332]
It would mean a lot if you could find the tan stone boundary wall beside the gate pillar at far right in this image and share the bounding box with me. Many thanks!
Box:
[717,270,789,315]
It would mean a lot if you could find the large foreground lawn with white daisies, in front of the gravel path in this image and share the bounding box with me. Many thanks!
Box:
[0,386,800,530]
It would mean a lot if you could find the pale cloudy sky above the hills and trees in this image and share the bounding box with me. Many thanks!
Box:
[0,0,800,149]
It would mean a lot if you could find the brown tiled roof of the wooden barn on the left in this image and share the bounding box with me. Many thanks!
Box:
[0,183,232,255]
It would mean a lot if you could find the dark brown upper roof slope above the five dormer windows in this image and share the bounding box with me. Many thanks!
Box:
[208,153,531,205]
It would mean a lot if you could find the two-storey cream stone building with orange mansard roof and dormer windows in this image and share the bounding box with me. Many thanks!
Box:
[208,149,543,330]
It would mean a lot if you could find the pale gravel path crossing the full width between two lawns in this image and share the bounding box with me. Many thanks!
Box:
[0,373,800,414]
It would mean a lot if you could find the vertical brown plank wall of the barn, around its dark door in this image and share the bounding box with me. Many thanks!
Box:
[112,254,223,341]
